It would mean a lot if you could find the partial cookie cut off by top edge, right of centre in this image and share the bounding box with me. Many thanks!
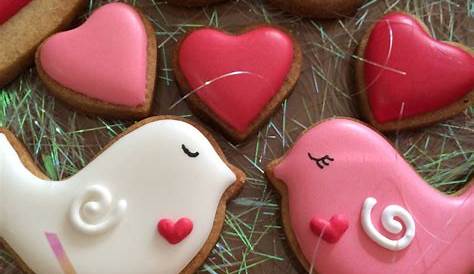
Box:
[270,0,364,19]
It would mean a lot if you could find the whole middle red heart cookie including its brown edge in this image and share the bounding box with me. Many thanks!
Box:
[174,25,302,142]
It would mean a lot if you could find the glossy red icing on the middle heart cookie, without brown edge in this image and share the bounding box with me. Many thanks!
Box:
[178,26,294,133]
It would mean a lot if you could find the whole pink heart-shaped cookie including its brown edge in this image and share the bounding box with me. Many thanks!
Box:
[36,3,157,118]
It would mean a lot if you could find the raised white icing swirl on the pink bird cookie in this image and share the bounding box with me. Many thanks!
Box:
[361,197,415,251]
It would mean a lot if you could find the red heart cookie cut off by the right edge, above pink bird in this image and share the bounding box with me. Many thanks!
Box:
[356,12,474,131]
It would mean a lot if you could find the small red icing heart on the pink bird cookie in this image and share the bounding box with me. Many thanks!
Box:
[310,214,349,244]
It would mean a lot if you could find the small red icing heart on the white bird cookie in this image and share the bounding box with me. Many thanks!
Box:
[157,218,193,245]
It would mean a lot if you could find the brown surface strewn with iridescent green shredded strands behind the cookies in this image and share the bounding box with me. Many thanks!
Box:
[0,0,474,273]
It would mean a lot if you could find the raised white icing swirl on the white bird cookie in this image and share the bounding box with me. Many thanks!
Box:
[70,185,127,235]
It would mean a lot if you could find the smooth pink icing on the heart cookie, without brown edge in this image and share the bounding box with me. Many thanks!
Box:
[40,3,148,107]
